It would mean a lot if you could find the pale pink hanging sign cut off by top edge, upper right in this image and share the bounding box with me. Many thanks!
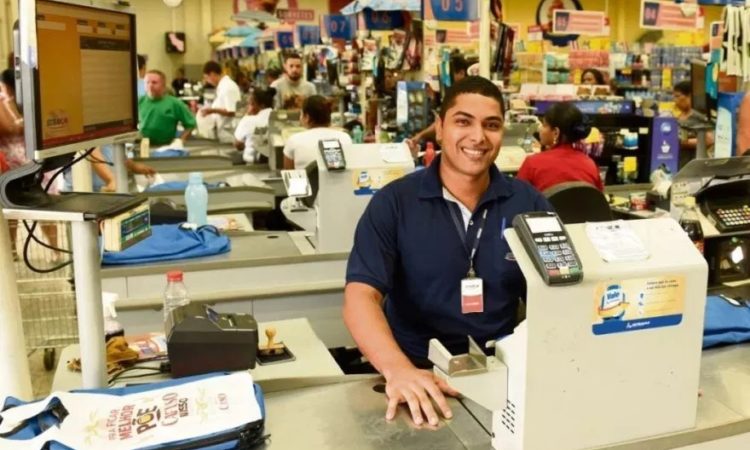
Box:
[641,0,704,31]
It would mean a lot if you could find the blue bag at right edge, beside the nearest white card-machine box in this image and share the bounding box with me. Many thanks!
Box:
[703,295,750,349]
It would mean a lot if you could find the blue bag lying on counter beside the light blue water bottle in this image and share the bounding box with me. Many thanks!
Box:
[102,224,232,265]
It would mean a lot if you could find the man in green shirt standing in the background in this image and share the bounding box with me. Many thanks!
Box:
[138,70,196,146]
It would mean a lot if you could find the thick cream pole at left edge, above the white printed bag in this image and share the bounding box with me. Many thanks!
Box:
[0,208,33,402]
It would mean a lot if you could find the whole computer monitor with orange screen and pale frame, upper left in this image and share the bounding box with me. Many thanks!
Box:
[19,0,138,164]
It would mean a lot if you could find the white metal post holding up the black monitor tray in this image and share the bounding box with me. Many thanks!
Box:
[72,221,107,389]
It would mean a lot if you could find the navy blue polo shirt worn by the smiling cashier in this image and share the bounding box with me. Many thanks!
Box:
[346,157,552,360]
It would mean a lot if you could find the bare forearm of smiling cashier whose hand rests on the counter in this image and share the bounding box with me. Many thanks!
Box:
[344,283,412,379]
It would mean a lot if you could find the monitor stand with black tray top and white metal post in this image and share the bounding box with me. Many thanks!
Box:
[0,162,146,389]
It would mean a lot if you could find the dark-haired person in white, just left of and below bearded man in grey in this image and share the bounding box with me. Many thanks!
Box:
[234,87,276,164]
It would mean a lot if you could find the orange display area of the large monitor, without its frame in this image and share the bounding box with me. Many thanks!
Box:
[36,0,137,150]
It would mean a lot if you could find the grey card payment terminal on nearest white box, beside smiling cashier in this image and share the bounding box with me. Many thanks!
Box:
[513,212,583,285]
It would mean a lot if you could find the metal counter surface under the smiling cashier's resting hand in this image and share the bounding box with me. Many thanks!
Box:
[261,377,490,450]
